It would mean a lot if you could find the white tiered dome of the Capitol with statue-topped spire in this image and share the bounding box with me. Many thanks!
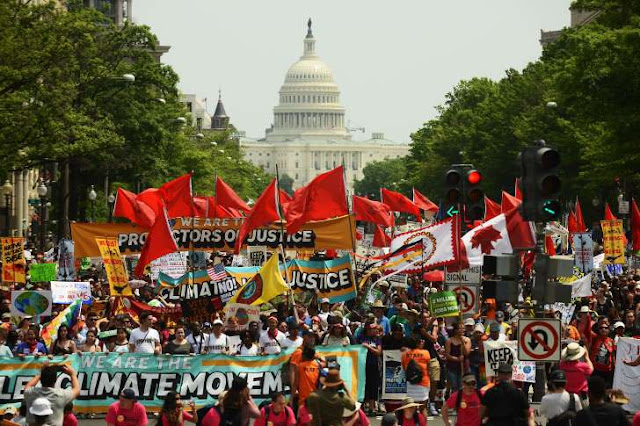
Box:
[266,19,351,141]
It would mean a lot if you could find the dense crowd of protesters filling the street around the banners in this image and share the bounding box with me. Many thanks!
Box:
[0,246,640,426]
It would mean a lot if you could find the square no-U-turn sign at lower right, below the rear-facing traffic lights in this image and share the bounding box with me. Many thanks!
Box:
[518,318,562,362]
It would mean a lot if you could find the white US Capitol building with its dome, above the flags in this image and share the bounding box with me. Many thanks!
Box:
[238,20,409,191]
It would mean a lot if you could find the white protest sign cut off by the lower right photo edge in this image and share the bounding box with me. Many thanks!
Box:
[613,337,640,413]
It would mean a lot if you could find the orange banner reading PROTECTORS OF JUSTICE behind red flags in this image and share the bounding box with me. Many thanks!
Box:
[71,216,355,257]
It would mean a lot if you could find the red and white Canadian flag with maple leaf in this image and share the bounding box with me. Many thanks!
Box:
[460,208,536,268]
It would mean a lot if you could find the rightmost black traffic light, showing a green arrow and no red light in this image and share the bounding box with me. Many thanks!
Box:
[520,141,562,222]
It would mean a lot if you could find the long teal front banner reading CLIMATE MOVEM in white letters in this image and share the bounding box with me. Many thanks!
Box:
[0,345,367,413]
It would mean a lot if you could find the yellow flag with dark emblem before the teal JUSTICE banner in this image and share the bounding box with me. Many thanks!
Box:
[227,253,289,305]
